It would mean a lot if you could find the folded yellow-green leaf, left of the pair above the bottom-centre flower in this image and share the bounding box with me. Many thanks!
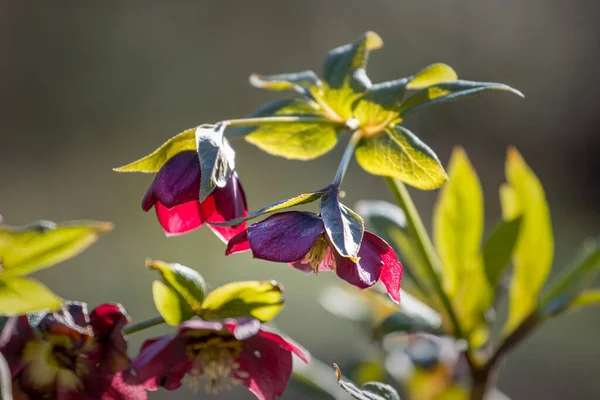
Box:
[146,260,207,326]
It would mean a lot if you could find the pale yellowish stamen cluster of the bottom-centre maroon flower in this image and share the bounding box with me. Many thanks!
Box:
[184,332,248,393]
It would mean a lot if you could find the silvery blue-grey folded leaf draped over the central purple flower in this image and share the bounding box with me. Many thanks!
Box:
[321,189,365,261]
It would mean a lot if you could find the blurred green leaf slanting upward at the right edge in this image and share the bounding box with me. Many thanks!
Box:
[541,239,600,313]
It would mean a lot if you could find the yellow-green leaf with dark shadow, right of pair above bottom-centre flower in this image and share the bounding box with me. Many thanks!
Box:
[201,281,283,322]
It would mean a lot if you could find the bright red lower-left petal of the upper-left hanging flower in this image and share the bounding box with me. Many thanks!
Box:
[155,201,202,236]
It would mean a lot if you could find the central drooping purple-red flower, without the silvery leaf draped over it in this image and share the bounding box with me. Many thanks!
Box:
[225,211,402,302]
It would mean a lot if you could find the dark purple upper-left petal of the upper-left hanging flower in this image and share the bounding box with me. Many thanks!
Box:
[142,150,200,211]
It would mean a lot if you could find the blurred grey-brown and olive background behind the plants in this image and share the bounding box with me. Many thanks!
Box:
[0,0,600,400]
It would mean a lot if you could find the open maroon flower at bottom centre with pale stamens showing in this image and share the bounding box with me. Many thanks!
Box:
[132,318,308,400]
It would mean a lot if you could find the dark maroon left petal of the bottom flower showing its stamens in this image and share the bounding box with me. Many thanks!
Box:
[131,336,192,390]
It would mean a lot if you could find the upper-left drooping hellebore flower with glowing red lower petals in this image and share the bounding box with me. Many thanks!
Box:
[142,151,248,242]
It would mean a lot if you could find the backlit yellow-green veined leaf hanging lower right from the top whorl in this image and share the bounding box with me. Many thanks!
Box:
[356,125,448,190]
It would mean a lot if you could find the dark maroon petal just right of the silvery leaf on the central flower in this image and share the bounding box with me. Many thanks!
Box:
[335,231,389,289]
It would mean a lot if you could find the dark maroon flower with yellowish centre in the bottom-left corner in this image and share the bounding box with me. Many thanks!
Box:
[0,302,147,400]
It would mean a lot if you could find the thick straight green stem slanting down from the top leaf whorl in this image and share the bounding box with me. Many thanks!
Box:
[385,178,465,339]
